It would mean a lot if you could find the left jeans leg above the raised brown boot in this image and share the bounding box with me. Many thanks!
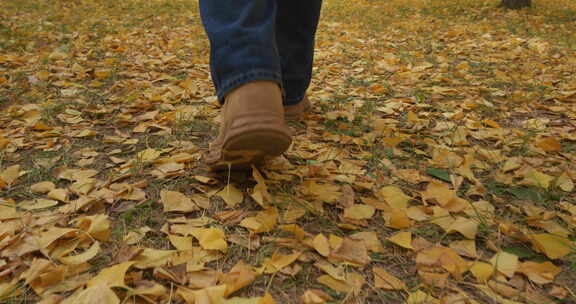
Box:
[200,0,290,102]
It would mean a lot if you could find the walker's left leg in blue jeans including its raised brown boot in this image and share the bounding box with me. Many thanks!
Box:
[200,0,291,170]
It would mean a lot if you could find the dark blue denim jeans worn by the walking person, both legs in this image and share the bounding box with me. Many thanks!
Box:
[200,0,322,105]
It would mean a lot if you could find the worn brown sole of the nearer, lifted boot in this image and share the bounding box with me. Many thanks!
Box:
[211,130,292,171]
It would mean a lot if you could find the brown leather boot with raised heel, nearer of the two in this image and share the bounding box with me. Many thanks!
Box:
[206,81,292,171]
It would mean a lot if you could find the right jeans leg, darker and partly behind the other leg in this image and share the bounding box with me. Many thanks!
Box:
[276,0,322,106]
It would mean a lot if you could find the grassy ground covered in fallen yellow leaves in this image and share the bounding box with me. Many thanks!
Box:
[0,0,576,304]
